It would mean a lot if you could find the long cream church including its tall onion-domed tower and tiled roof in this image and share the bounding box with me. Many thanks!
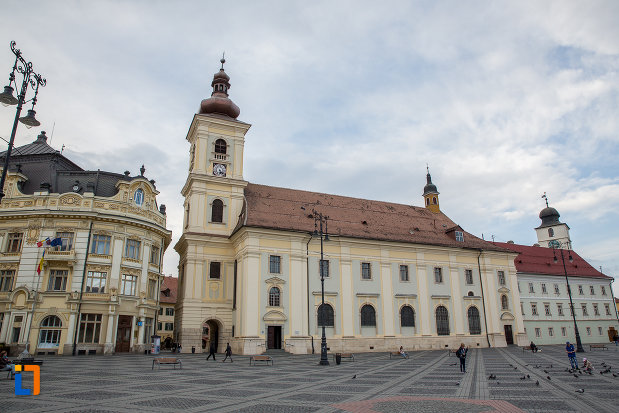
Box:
[175,59,528,354]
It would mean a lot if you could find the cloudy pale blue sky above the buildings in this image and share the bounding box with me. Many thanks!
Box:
[0,0,619,280]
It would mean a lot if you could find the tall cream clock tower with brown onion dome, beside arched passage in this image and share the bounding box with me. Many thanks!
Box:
[174,58,251,351]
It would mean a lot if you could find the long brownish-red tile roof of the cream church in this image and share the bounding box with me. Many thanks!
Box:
[235,183,505,251]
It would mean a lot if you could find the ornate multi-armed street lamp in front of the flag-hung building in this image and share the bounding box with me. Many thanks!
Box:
[0,41,47,202]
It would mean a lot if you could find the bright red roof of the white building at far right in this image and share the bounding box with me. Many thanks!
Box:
[495,242,612,279]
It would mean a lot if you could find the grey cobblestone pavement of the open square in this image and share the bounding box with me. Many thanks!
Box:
[0,345,619,413]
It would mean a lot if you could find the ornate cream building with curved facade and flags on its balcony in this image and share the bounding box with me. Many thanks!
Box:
[0,132,171,354]
